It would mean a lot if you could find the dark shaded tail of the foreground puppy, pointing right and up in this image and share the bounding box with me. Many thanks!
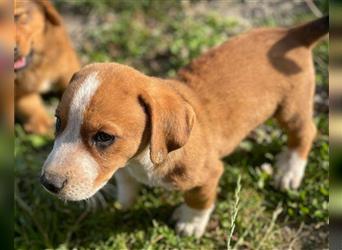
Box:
[289,16,329,47]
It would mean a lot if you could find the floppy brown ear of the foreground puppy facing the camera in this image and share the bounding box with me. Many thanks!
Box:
[140,83,195,164]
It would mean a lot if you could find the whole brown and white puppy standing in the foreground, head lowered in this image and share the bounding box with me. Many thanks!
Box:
[41,18,328,237]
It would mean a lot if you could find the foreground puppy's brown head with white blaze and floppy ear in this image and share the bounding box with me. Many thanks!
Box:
[41,64,194,200]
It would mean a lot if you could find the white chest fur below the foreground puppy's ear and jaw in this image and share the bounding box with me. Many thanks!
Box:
[126,149,172,189]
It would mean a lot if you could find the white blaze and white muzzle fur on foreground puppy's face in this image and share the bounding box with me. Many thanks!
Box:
[43,73,100,199]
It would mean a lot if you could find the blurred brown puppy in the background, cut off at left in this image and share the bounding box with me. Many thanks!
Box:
[14,0,80,134]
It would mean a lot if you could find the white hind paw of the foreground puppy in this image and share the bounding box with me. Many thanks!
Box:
[274,150,306,190]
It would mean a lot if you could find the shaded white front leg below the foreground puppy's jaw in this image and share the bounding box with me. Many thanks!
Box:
[114,168,140,210]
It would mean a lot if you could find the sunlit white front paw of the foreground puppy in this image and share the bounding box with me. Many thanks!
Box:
[172,204,214,238]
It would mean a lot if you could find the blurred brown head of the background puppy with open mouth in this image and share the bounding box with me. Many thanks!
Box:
[14,0,61,71]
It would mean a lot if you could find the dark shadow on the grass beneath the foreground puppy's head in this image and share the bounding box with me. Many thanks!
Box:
[15,183,175,249]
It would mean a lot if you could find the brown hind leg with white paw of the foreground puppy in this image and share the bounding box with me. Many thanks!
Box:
[274,89,316,190]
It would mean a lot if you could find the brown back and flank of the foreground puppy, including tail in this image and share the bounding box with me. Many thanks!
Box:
[179,18,328,154]
